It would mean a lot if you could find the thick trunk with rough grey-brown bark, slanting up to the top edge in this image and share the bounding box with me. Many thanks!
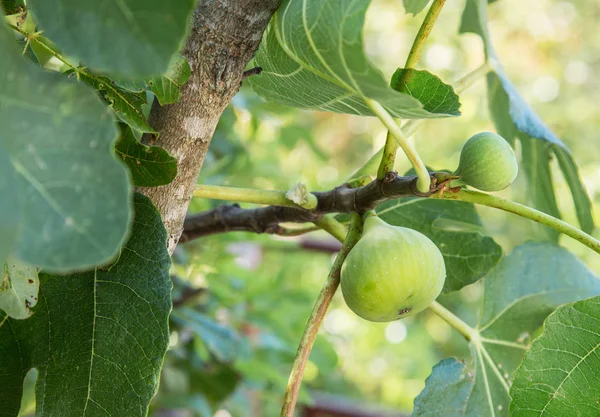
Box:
[138,0,279,253]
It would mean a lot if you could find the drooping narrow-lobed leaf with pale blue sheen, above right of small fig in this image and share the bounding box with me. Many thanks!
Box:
[460,0,594,234]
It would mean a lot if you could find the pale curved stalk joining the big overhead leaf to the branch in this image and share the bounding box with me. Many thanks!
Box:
[365,98,431,193]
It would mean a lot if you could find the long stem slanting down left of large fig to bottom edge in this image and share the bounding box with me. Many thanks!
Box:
[280,213,362,417]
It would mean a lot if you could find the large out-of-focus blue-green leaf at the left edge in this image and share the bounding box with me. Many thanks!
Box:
[0,23,131,271]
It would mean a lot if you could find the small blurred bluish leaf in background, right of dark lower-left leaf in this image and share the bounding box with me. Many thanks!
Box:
[173,307,240,362]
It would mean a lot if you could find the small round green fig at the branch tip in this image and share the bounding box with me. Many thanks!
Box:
[455,132,519,191]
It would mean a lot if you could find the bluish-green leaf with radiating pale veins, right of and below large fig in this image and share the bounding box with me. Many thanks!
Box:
[415,243,600,417]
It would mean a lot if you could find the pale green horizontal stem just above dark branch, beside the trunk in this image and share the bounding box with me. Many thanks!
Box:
[193,184,308,207]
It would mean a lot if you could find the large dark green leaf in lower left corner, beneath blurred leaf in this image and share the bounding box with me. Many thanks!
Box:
[0,195,171,417]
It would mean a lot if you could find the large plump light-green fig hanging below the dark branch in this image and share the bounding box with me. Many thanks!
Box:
[341,216,446,321]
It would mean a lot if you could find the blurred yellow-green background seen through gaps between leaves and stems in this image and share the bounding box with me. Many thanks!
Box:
[18,0,600,417]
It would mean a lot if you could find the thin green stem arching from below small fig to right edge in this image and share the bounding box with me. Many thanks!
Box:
[430,190,600,254]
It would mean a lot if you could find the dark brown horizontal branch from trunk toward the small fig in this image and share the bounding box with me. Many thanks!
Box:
[180,172,438,242]
